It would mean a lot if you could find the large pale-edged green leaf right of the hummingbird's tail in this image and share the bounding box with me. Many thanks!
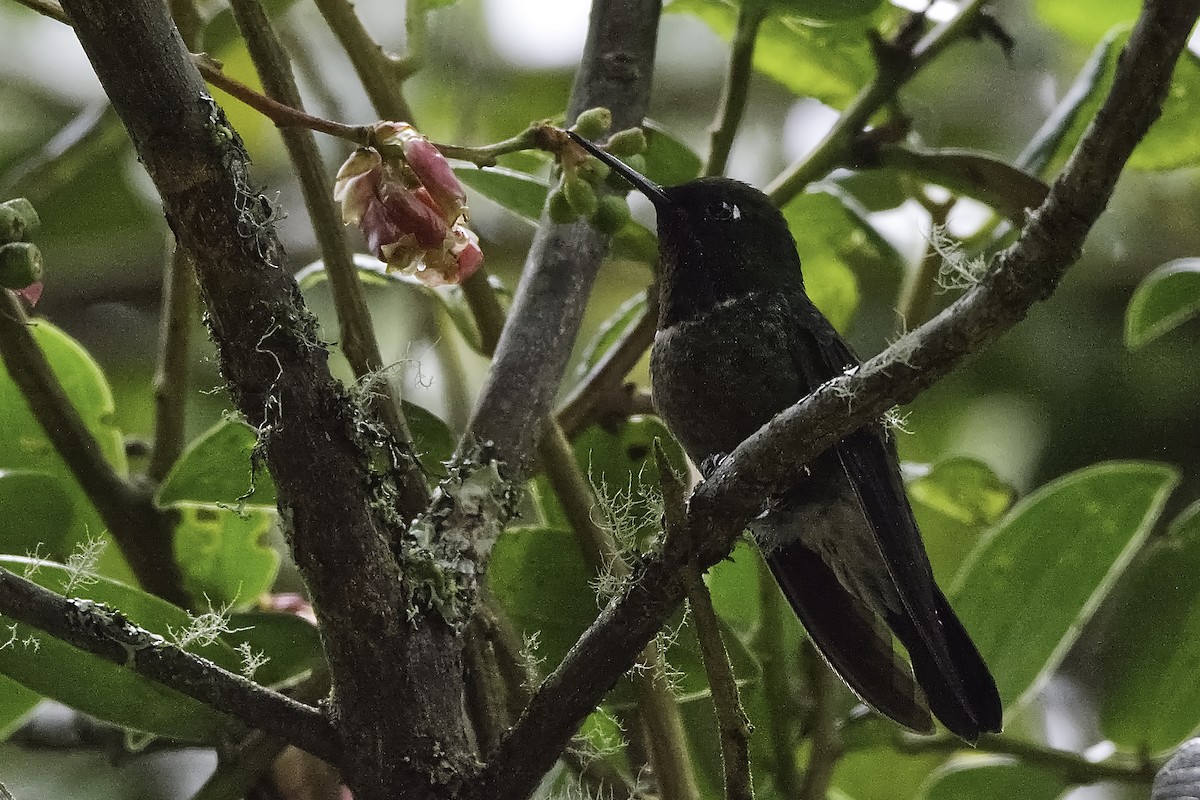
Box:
[950,462,1178,706]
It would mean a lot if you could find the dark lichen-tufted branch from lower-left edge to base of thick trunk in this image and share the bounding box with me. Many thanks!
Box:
[0,567,338,764]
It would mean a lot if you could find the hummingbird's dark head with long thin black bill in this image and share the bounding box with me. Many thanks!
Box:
[569,132,804,321]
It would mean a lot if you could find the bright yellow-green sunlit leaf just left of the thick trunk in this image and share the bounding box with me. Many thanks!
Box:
[173,503,280,607]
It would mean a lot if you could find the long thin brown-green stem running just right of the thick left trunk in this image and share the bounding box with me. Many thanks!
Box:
[232,0,430,515]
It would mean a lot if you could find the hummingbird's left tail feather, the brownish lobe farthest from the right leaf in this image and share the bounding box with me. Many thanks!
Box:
[766,545,936,733]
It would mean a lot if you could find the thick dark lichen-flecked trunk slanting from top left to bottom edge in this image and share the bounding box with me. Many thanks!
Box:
[57,0,474,800]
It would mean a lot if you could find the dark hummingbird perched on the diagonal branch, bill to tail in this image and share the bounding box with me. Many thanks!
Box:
[569,132,1002,742]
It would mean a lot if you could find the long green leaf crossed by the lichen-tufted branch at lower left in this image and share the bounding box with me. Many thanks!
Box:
[0,557,240,741]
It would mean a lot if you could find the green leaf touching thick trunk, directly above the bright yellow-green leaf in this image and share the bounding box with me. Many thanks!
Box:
[157,420,276,509]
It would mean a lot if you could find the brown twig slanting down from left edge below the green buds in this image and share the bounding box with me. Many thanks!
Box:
[0,289,190,608]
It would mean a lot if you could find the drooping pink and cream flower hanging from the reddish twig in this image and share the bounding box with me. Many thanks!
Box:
[334,122,484,285]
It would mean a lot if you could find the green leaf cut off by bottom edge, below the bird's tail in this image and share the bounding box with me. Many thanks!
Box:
[917,756,1070,800]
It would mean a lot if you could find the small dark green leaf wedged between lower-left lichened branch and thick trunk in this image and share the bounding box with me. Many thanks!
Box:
[221,612,325,686]
